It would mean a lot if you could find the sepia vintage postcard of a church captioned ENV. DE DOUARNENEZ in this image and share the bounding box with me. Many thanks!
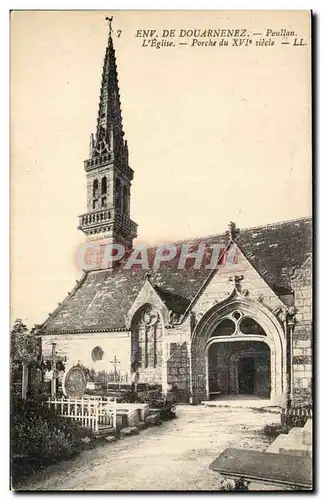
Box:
[10,10,314,492]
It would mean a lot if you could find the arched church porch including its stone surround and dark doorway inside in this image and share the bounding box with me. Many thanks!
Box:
[191,293,286,405]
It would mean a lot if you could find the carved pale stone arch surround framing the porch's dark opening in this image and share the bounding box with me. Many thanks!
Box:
[191,293,286,404]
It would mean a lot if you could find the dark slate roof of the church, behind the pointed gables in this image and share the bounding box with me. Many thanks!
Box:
[39,218,312,334]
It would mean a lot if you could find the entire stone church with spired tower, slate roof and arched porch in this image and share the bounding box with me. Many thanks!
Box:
[38,29,312,406]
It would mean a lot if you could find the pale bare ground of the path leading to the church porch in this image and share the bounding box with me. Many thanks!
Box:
[19,406,279,490]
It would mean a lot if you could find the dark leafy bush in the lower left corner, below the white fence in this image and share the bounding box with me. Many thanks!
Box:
[11,399,92,486]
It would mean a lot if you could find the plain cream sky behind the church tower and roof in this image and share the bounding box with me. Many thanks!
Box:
[11,11,311,326]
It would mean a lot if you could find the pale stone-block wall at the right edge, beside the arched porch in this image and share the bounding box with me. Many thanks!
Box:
[292,259,312,403]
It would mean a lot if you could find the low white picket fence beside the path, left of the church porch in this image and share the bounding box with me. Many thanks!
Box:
[46,397,116,433]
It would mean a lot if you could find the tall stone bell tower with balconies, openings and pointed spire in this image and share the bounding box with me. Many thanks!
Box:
[78,18,137,249]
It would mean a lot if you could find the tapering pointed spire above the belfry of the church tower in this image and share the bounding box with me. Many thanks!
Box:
[92,17,125,157]
